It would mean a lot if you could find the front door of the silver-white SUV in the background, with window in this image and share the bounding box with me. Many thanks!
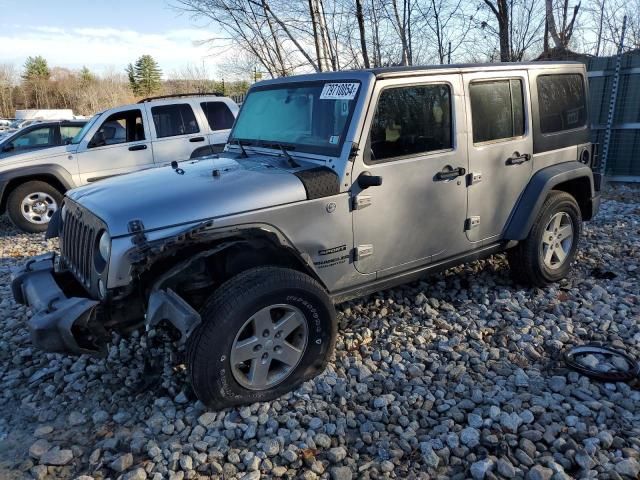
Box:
[77,107,154,184]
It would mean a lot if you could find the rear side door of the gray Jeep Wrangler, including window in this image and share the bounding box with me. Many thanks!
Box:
[463,71,533,243]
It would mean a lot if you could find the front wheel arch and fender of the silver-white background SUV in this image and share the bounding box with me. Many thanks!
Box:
[0,165,75,214]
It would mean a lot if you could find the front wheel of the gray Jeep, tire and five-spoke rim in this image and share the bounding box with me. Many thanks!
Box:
[187,267,336,409]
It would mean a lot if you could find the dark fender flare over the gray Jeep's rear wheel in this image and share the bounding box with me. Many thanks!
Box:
[504,162,599,240]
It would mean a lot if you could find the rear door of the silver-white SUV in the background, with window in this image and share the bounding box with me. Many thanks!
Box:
[146,102,209,165]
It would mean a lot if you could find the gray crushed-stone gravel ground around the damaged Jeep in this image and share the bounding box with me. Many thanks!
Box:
[0,187,640,480]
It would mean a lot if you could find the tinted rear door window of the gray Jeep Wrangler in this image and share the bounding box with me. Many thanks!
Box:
[469,79,524,143]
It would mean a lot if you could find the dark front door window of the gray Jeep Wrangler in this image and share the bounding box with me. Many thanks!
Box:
[371,84,453,161]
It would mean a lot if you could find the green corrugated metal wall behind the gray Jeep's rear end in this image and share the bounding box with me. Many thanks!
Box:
[586,51,640,180]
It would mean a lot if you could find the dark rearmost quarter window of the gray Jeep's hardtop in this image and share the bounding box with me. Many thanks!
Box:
[537,73,587,133]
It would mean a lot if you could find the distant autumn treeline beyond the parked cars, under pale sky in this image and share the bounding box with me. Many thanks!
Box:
[0,55,249,118]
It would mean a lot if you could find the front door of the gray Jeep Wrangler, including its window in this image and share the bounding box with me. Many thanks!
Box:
[352,75,469,278]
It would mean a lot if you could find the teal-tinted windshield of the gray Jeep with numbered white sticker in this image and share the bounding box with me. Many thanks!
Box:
[229,81,360,156]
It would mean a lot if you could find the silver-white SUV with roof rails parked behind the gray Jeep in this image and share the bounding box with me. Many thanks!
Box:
[0,95,238,232]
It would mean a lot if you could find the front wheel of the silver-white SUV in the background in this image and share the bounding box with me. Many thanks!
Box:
[7,180,63,233]
